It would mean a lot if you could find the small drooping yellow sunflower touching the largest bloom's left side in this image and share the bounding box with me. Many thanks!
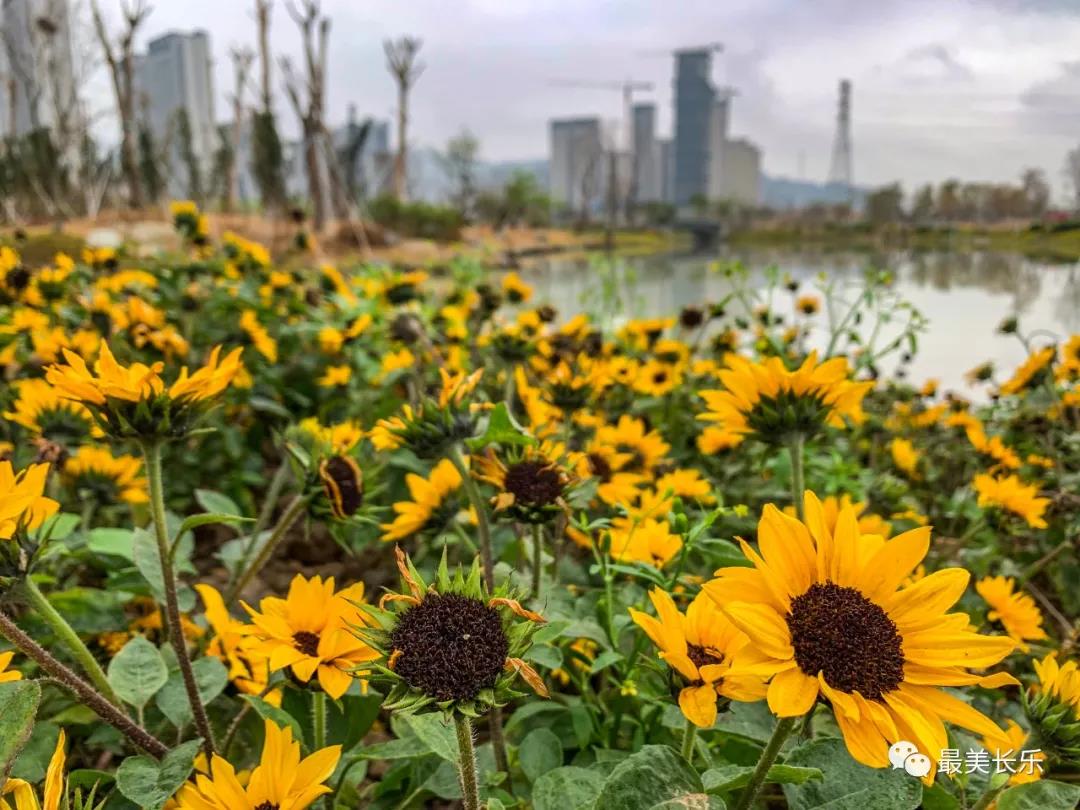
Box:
[630,588,766,728]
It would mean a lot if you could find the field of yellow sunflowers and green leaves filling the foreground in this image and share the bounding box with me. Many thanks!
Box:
[0,210,1080,810]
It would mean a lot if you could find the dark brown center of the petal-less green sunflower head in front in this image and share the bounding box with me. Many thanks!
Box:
[390,594,510,701]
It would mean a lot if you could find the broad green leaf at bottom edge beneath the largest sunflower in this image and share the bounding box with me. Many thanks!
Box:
[784,738,922,810]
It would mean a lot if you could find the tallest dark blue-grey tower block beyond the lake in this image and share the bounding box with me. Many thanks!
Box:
[673,49,716,205]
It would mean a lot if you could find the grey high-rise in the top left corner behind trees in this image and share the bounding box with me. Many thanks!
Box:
[0,0,80,136]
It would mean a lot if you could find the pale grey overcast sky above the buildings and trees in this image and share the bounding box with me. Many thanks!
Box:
[86,0,1080,190]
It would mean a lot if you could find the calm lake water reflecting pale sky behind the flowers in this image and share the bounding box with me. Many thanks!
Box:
[523,249,1080,399]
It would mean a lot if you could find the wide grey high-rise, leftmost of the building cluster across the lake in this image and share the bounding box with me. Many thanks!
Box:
[550,118,609,214]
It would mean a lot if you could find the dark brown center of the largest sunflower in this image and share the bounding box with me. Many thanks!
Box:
[785,582,904,700]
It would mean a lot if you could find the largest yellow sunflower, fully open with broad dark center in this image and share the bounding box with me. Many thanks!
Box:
[704,491,1016,781]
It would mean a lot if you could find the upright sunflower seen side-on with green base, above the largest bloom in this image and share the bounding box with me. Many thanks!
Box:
[698,352,874,443]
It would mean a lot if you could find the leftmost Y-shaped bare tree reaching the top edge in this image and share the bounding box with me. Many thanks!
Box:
[91,0,150,208]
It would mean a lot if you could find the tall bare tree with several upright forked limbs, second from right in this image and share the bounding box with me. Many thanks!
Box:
[281,0,330,233]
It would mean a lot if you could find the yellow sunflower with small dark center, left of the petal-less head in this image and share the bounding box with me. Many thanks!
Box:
[244,575,378,700]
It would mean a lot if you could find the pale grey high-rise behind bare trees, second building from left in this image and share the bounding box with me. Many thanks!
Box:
[135,30,218,197]
